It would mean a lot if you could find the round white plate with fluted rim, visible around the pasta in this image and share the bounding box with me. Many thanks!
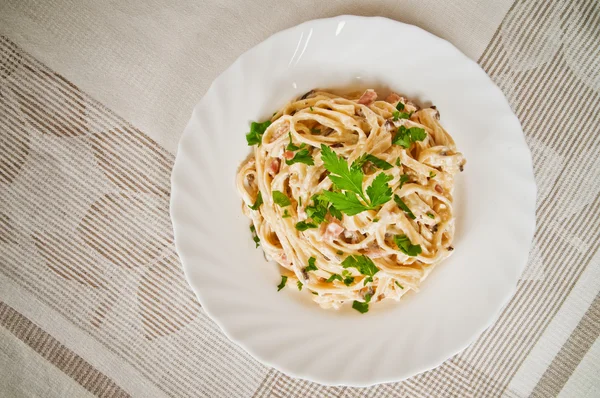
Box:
[171,16,536,386]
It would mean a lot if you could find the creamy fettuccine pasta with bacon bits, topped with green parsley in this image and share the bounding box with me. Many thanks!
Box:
[236,89,465,313]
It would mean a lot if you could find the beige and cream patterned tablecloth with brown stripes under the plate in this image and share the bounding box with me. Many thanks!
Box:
[0,0,600,397]
